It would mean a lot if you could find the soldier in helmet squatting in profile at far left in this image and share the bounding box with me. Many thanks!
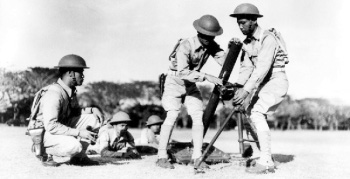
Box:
[37,55,103,166]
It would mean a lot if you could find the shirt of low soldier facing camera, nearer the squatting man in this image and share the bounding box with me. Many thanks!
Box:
[98,128,135,151]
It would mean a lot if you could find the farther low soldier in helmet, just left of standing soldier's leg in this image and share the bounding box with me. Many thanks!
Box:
[140,115,163,147]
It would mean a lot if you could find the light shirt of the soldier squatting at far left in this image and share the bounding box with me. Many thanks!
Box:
[37,79,81,136]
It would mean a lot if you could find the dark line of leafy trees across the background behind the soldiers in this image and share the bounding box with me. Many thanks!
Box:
[0,67,350,130]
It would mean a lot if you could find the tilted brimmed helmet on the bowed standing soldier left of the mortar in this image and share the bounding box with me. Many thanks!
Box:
[193,15,223,36]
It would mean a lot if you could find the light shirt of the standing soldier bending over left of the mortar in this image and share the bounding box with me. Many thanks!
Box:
[170,36,226,82]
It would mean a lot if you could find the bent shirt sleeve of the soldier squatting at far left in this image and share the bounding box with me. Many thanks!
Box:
[40,90,79,136]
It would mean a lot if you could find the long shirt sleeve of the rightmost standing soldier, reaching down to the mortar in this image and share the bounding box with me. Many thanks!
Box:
[244,35,277,93]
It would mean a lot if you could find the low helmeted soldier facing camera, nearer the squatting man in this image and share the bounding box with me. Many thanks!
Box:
[98,111,141,159]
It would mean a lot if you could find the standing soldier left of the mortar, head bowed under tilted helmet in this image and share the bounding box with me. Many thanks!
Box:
[156,15,230,169]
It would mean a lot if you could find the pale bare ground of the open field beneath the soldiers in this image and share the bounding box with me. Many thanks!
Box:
[0,124,350,179]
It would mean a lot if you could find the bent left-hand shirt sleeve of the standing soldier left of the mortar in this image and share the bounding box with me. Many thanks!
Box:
[176,40,205,82]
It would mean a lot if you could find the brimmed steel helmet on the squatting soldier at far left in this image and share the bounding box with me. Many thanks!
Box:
[55,54,89,68]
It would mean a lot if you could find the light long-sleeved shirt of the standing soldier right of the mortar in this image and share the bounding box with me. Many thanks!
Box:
[237,26,286,93]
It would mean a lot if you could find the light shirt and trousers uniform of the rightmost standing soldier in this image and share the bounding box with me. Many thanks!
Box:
[237,26,289,169]
